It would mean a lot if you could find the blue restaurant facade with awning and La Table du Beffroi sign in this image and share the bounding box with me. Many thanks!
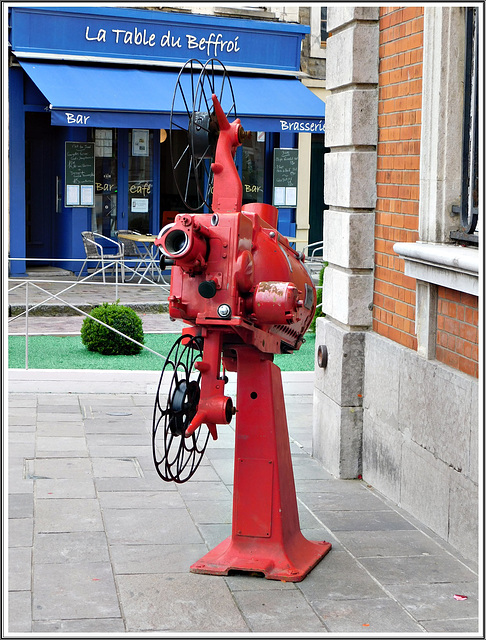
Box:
[8,5,325,276]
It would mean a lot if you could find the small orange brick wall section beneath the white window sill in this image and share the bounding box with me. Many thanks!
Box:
[436,287,478,378]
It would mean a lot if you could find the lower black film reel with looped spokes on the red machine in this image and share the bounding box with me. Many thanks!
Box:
[152,336,210,483]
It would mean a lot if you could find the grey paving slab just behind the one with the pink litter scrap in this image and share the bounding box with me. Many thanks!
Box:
[361,556,477,585]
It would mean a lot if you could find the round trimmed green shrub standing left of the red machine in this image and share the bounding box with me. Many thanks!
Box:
[81,300,144,356]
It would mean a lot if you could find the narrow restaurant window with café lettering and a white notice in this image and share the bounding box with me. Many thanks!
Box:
[128,129,154,233]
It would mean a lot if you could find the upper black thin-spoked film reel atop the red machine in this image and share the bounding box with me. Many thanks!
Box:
[169,58,237,211]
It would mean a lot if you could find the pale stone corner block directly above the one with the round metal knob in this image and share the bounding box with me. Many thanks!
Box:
[322,264,373,327]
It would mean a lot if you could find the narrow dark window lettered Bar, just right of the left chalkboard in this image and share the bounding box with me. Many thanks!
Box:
[91,129,118,238]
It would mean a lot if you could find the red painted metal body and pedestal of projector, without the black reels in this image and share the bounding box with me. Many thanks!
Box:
[157,96,331,581]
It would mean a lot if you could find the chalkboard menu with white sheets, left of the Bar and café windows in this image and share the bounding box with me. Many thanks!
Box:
[65,142,95,207]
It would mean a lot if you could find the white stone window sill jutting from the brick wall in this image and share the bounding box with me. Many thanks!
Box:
[393,242,479,296]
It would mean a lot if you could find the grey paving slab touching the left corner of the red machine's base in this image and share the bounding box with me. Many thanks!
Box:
[110,540,207,574]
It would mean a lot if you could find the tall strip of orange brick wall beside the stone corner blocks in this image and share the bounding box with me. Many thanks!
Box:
[373,7,423,349]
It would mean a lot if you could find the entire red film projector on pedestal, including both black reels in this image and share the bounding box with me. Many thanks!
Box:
[153,60,331,582]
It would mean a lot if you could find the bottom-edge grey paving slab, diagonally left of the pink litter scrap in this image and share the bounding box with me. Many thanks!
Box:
[312,597,425,636]
